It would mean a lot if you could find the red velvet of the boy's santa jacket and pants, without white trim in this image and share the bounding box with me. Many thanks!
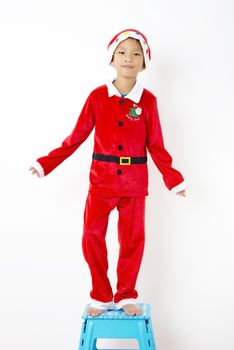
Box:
[37,85,184,303]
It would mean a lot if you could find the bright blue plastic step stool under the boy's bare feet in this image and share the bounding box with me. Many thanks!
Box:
[79,303,156,350]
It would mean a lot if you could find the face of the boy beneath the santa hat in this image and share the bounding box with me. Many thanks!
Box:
[112,38,144,78]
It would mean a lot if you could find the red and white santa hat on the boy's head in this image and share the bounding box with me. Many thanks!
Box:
[107,29,151,67]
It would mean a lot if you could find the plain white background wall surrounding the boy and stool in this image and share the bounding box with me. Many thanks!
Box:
[0,0,234,350]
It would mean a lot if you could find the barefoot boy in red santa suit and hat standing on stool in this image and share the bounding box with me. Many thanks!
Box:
[29,29,185,316]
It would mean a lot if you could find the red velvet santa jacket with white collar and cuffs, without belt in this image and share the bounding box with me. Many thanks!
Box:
[35,80,185,196]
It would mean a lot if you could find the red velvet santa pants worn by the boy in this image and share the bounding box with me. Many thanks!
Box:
[82,192,146,303]
